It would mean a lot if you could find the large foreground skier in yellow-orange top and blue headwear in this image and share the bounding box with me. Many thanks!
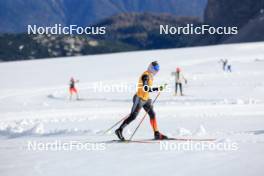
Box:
[115,61,168,141]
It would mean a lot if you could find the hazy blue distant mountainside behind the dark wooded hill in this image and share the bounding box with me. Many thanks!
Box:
[0,0,207,32]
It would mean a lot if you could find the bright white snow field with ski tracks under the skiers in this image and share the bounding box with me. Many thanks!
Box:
[0,43,264,176]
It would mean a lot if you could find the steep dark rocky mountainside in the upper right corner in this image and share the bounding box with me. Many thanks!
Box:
[204,0,264,43]
